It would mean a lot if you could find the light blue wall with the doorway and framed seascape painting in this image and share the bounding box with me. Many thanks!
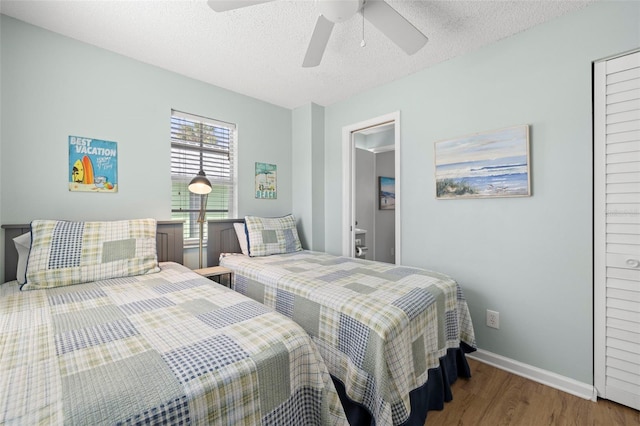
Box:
[325,2,640,383]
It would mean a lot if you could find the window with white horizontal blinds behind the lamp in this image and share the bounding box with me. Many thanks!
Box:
[171,110,237,244]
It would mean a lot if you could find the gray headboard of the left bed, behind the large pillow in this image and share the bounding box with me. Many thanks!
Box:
[2,220,184,282]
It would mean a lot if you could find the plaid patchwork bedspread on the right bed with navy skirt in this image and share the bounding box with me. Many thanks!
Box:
[220,251,476,425]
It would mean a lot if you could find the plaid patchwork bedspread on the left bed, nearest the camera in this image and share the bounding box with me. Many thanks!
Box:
[0,263,347,425]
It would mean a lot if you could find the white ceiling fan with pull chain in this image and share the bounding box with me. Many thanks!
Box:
[208,0,429,67]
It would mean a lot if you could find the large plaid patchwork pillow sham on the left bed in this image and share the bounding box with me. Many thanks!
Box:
[21,219,160,290]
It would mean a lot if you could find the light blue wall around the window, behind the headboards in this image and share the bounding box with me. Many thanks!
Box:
[0,15,292,276]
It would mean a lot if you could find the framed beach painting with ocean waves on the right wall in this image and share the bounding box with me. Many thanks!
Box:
[434,125,531,199]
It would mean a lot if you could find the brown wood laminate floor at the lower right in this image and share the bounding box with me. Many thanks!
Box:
[425,358,640,426]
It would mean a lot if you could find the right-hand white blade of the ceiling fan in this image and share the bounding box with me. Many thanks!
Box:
[363,0,429,55]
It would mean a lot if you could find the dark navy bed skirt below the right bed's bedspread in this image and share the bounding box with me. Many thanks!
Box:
[331,342,475,426]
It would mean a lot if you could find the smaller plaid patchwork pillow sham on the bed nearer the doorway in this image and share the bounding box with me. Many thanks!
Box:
[244,215,302,257]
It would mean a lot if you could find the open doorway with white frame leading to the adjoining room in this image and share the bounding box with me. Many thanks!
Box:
[342,112,401,264]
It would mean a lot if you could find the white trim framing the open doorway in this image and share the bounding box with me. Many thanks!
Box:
[342,111,402,265]
